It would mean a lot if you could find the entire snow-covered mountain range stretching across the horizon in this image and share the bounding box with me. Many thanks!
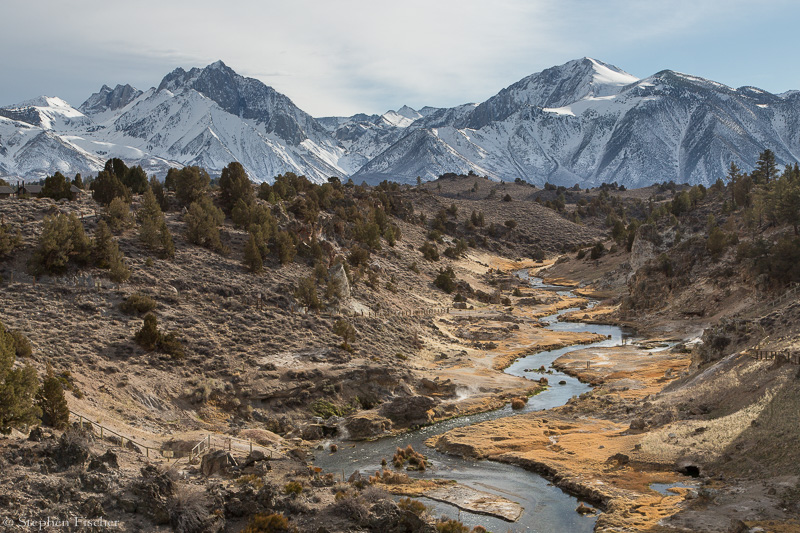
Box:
[0,58,800,187]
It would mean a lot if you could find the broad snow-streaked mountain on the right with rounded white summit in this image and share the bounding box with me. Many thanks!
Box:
[353,58,800,187]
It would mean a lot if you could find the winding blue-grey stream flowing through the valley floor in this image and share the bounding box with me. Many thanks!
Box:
[314,270,629,533]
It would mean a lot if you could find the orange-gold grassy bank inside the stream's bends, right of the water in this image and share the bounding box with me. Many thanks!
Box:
[428,347,693,531]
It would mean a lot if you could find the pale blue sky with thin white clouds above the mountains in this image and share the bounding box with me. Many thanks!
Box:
[0,0,800,117]
